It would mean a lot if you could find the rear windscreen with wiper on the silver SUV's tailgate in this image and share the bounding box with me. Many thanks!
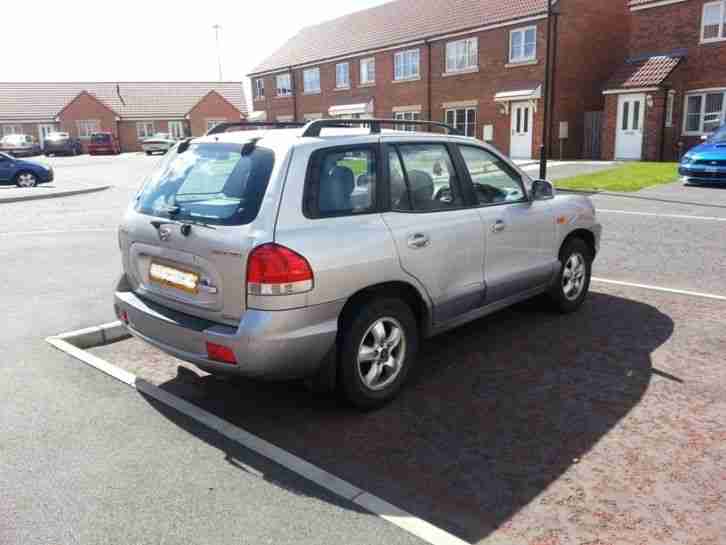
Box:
[136,144,275,225]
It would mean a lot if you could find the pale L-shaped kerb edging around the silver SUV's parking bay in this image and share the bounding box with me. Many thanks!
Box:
[46,322,468,545]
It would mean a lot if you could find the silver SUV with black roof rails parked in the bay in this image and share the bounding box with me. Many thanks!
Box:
[115,120,601,409]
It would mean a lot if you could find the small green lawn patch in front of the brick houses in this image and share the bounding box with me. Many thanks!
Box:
[555,163,678,191]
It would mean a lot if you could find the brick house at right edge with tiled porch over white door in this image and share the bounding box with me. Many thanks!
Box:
[602,0,726,161]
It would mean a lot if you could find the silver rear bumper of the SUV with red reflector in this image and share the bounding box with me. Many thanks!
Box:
[114,280,344,379]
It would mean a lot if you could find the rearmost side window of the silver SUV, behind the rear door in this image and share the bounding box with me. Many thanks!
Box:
[306,147,377,217]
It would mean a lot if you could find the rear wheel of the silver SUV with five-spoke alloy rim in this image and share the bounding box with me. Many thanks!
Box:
[337,298,419,411]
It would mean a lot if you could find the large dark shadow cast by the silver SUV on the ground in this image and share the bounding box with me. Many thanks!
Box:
[142,293,674,542]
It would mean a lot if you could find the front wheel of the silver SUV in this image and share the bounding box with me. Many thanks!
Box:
[548,238,594,314]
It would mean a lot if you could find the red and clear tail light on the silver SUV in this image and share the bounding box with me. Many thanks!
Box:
[247,244,313,295]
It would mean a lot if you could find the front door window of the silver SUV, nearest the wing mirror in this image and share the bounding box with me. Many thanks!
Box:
[459,146,526,204]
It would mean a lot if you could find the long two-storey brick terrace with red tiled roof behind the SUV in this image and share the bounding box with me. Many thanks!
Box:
[250,0,628,158]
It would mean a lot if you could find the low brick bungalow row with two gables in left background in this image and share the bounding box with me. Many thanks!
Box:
[0,82,247,151]
